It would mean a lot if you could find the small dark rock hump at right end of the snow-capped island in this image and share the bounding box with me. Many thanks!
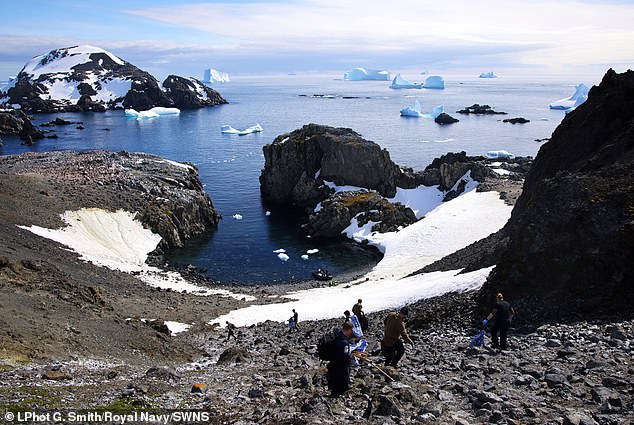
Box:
[163,75,228,109]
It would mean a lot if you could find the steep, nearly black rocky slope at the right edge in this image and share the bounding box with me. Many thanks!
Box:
[480,70,634,320]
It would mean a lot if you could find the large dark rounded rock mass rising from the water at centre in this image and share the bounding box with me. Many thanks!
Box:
[260,124,403,206]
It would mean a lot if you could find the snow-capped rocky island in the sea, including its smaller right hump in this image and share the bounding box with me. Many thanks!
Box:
[0,46,227,112]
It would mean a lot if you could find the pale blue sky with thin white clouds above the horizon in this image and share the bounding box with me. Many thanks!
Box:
[0,0,634,80]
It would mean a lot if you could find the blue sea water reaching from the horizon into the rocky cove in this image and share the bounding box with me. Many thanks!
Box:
[0,75,584,284]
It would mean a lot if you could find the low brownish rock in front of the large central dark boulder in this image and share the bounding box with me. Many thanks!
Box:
[304,190,416,237]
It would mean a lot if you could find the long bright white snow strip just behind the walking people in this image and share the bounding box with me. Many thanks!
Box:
[211,267,492,326]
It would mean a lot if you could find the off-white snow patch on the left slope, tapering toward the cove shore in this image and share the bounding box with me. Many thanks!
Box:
[19,208,254,300]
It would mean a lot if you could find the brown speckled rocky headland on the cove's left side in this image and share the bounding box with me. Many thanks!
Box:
[0,151,220,250]
